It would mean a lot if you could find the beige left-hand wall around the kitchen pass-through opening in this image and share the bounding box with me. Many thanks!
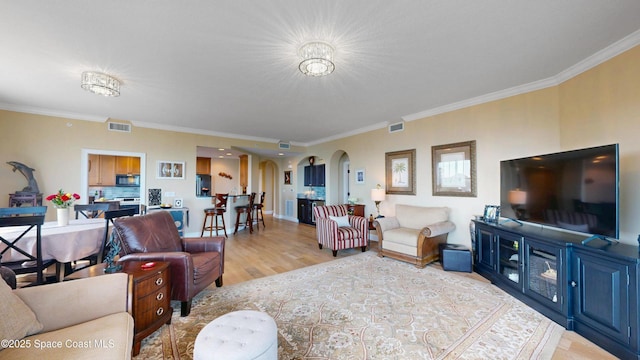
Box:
[0,114,277,235]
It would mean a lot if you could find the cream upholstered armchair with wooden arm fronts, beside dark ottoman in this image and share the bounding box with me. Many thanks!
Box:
[374,205,456,268]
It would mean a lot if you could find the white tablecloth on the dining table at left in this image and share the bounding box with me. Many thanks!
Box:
[0,219,106,263]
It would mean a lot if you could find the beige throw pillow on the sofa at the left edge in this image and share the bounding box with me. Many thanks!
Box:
[0,281,43,342]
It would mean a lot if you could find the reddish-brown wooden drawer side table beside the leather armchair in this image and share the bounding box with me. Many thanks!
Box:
[65,261,173,356]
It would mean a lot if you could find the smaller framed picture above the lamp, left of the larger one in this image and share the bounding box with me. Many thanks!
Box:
[385,149,416,195]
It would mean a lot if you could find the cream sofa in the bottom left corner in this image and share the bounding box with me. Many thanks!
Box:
[0,273,134,360]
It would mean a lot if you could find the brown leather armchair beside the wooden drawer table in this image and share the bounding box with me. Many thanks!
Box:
[113,211,225,316]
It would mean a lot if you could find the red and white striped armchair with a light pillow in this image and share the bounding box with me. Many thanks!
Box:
[313,205,369,256]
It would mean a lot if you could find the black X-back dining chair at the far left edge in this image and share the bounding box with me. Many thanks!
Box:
[0,206,55,285]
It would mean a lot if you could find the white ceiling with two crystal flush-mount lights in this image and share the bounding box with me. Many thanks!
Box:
[0,0,640,145]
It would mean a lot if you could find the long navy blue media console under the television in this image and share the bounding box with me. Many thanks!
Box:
[473,220,640,359]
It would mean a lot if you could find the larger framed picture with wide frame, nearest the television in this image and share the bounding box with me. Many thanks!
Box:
[431,140,477,197]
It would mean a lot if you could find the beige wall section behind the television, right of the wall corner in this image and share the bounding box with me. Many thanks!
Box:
[559,46,640,244]
